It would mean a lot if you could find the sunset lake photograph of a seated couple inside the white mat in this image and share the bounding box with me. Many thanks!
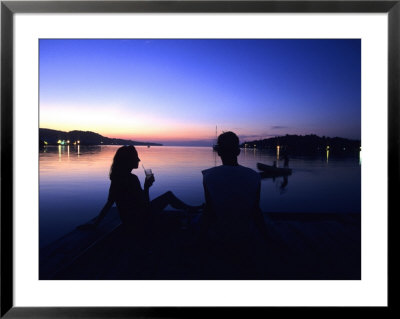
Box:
[38,38,362,281]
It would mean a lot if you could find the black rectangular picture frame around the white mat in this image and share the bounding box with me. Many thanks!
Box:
[0,0,400,318]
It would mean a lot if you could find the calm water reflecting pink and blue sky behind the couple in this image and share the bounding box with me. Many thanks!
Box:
[39,146,361,247]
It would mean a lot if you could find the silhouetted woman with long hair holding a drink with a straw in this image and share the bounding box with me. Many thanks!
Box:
[89,146,202,234]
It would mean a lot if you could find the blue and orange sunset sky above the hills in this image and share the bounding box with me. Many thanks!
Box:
[39,39,361,145]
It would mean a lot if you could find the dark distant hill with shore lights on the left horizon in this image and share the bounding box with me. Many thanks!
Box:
[39,128,162,146]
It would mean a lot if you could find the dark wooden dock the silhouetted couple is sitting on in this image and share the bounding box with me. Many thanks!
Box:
[39,208,361,280]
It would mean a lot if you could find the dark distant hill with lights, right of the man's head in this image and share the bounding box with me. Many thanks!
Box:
[241,134,361,154]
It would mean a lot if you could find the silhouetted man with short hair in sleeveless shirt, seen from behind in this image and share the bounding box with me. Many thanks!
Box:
[202,132,266,249]
